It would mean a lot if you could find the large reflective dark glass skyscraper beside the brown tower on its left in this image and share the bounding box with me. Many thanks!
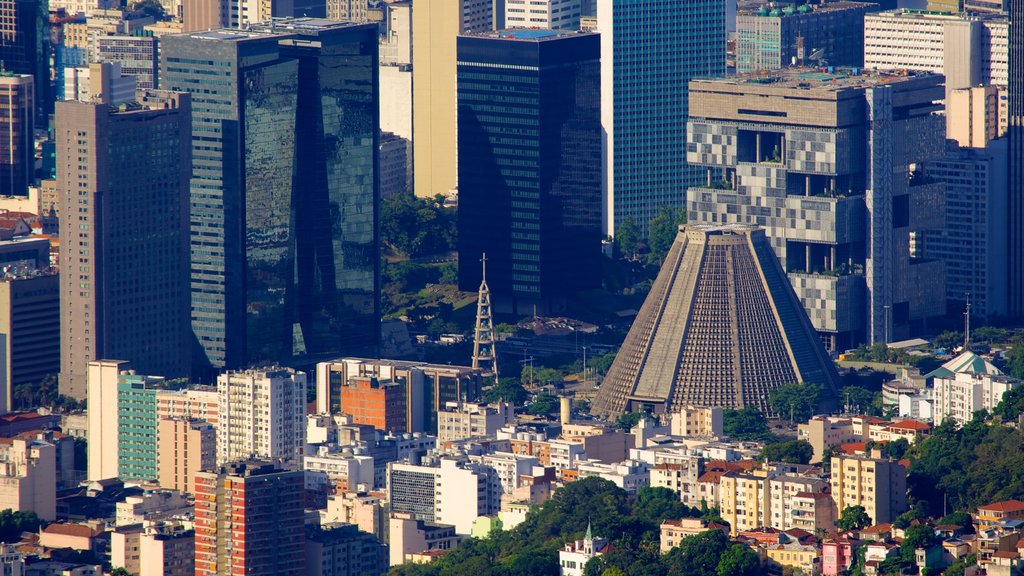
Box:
[161,18,379,370]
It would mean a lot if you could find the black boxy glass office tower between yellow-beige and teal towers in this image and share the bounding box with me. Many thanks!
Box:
[458,30,601,313]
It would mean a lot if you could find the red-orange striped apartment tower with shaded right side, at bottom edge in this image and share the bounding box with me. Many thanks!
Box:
[196,460,306,576]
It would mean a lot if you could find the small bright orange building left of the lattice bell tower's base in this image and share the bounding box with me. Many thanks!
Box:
[341,377,409,433]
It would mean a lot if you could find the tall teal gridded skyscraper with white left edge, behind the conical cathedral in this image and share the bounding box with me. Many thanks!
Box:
[598,0,726,235]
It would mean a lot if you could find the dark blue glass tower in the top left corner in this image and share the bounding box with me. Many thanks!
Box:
[0,0,53,121]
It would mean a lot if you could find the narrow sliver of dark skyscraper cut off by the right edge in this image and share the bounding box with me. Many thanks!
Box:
[1008,0,1024,318]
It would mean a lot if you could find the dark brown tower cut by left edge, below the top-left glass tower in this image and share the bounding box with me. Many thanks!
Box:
[0,73,32,196]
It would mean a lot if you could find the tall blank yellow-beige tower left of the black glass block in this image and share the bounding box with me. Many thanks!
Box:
[413,0,495,197]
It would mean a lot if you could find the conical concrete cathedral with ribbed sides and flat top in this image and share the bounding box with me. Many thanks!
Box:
[591,225,839,418]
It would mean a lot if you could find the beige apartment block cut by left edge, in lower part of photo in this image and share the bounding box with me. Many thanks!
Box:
[0,438,57,522]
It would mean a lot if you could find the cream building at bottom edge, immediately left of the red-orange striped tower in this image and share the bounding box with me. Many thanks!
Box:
[138,521,196,576]
